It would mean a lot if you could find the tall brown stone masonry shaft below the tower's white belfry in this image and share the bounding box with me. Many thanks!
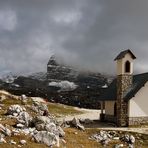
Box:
[117,74,133,126]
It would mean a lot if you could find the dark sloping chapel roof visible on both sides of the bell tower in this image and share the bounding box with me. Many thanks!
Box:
[99,73,148,101]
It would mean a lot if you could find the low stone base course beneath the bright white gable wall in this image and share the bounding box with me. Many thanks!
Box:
[128,117,148,126]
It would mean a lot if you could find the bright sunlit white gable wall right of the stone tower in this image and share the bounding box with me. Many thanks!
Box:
[129,82,148,117]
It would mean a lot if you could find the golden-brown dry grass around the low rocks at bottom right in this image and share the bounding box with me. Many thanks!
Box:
[54,128,148,148]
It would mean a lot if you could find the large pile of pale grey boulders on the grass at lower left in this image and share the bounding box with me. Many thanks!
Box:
[4,101,65,147]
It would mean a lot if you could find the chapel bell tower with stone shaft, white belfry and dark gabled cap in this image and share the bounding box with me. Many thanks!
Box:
[114,49,136,126]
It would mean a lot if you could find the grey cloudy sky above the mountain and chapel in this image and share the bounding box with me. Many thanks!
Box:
[0,0,148,74]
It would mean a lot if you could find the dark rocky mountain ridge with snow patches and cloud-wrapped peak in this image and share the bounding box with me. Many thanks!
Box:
[0,56,111,108]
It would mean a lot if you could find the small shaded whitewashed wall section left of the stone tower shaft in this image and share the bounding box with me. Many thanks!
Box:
[105,101,115,115]
